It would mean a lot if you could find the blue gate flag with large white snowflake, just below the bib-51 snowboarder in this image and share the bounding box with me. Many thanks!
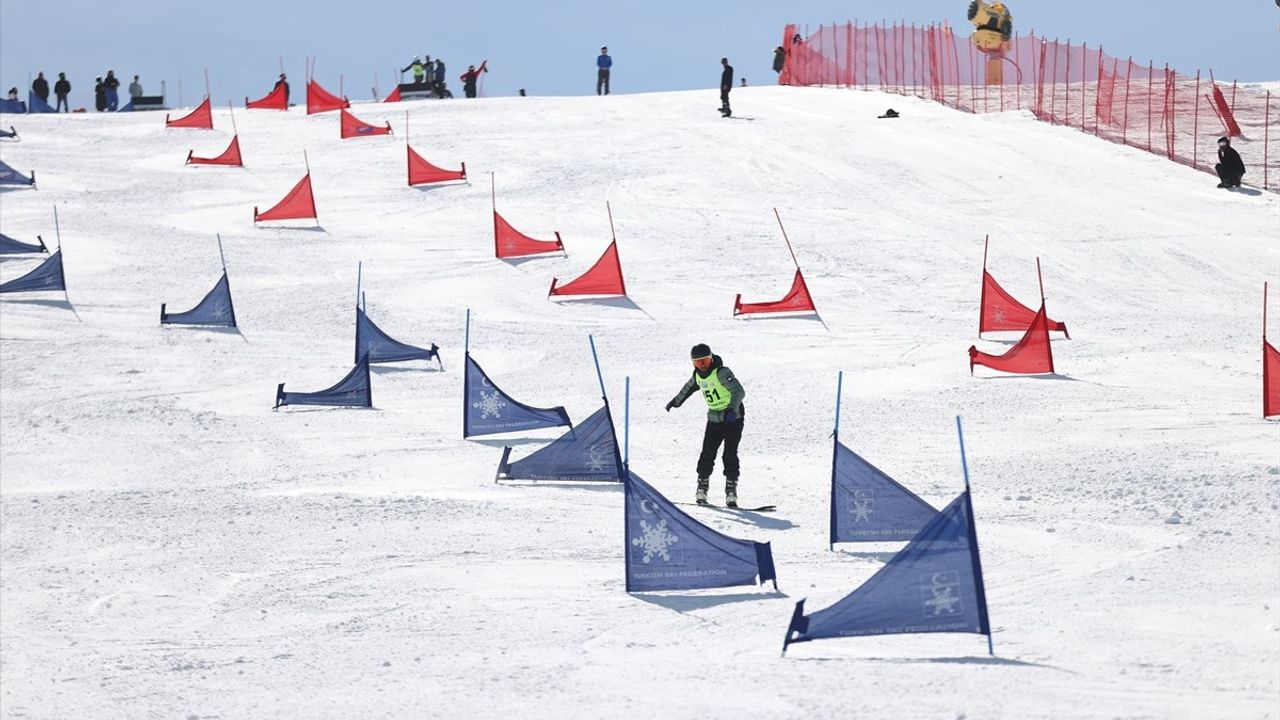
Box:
[625,471,778,592]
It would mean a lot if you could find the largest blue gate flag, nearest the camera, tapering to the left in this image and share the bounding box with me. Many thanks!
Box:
[782,491,991,651]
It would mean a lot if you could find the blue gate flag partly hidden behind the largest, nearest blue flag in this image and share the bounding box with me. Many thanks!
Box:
[831,438,938,543]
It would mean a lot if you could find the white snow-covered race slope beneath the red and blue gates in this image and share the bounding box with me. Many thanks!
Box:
[0,87,1280,719]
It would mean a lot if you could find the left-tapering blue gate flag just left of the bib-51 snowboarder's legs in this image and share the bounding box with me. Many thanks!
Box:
[498,401,626,483]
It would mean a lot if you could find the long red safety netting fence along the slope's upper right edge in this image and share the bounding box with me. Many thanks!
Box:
[778,22,1280,192]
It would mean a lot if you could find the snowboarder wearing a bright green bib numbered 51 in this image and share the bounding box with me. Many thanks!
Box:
[667,343,746,507]
